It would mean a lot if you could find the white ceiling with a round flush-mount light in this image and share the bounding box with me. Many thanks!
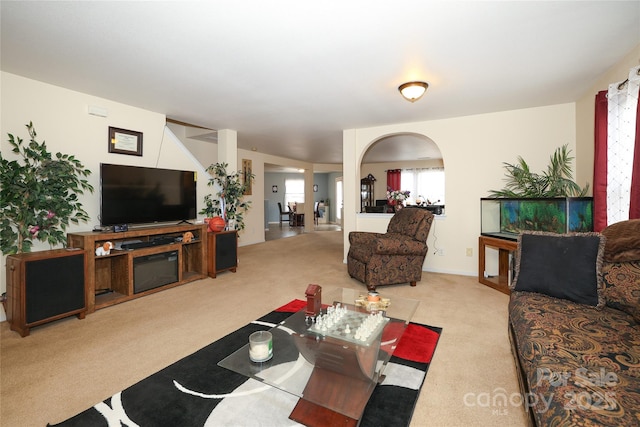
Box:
[0,0,640,164]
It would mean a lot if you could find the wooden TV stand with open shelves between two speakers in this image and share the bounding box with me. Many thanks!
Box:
[67,224,207,313]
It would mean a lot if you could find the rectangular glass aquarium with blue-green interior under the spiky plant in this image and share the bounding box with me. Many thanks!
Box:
[480,197,593,240]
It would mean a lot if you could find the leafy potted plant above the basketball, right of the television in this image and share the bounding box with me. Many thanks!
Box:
[200,163,255,230]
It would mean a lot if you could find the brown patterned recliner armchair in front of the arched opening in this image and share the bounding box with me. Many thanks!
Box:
[347,208,433,291]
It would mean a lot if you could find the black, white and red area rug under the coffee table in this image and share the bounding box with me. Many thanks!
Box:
[49,300,442,427]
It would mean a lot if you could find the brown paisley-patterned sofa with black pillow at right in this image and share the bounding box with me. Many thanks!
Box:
[509,220,640,426]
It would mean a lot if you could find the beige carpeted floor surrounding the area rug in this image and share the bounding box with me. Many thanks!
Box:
[0,232,525,427]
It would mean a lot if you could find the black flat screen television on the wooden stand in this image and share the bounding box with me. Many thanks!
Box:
[100,163,196,226]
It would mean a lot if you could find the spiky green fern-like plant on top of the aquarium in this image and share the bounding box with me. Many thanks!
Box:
[489,144,589,198]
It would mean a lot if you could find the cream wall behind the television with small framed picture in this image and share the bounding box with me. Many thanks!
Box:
[0,72,206,298]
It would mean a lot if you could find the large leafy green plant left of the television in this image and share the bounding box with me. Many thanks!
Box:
[0,122,93,254]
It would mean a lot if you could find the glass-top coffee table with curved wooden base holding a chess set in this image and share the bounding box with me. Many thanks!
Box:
[218,288,420,426]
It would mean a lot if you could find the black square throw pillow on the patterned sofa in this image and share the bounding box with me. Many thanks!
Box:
[511,232,605,308]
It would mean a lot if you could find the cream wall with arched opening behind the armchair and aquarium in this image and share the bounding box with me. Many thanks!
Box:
[343,104,576,275]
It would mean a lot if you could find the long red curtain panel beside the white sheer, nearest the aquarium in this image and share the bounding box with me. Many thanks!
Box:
[593,90,608,231]
